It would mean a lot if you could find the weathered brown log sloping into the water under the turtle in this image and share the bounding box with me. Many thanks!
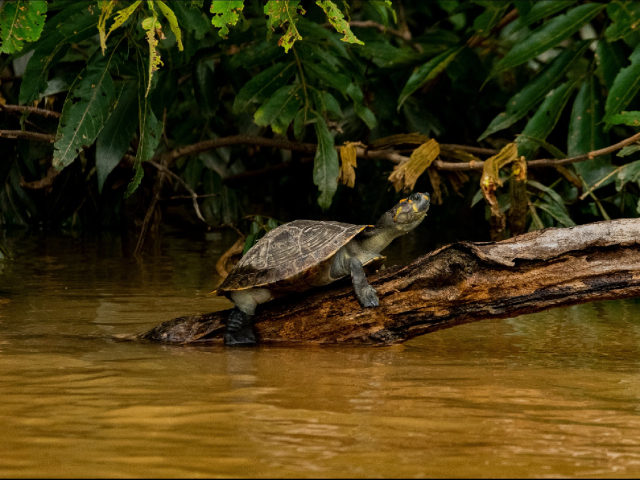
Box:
[138,219,640,345]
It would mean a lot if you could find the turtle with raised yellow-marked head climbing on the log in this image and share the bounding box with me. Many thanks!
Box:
[216,193,430,345]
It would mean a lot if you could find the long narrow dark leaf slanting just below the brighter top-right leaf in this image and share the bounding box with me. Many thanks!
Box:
[478,41,589,141]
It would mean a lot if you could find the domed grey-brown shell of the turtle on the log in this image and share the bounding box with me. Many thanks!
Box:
[217,220,370,295]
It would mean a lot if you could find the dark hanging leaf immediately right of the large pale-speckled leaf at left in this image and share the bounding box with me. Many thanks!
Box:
[96,82,138,193]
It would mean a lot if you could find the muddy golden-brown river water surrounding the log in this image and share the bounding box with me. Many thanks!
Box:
[0,232,640,477]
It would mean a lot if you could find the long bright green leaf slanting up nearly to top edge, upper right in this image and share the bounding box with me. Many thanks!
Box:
[491,3,605,77]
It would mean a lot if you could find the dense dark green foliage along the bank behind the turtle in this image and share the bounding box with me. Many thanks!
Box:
[0,0,640,246]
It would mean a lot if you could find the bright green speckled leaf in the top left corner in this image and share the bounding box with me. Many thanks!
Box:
[0,0,47,53]
